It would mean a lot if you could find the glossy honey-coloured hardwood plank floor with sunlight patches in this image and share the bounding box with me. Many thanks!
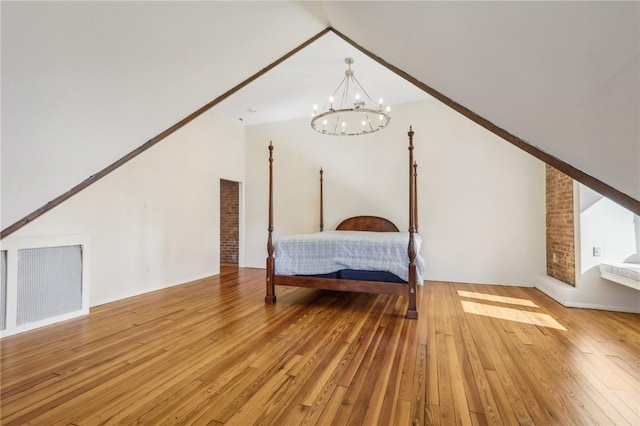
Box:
[0,268,640,426]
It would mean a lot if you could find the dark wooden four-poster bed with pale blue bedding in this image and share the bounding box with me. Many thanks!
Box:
[265,128,424,319]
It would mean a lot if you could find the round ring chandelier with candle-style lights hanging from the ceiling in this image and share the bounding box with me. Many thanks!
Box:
[311,58,391,136]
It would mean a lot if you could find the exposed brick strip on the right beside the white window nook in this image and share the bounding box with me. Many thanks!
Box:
[546,165,576,287]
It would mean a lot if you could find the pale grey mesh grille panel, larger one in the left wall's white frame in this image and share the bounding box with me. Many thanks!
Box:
[16,245,82,326]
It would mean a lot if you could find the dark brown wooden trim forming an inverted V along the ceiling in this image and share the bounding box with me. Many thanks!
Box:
[0,27,640,239]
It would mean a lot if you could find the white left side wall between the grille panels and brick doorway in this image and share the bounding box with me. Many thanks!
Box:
[2,111,244,306]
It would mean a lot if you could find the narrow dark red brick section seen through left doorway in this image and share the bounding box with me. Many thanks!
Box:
[220,179,240,265]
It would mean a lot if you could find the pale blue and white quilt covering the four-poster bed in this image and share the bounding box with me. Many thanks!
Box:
[275,231,424,284]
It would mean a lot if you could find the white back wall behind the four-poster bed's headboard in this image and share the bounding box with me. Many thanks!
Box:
[245,100,545,286]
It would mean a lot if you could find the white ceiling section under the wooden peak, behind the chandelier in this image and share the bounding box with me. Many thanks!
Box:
[214,32,429,125]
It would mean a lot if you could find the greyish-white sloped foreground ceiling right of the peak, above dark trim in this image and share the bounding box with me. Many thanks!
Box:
[325,2,640,200]
